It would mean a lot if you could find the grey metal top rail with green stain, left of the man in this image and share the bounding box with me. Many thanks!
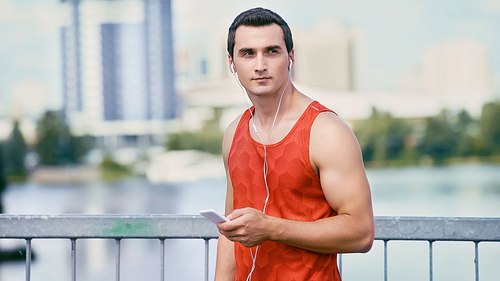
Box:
[0,215,219,238]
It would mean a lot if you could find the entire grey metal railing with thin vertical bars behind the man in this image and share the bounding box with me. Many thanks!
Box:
[0,215,500,281]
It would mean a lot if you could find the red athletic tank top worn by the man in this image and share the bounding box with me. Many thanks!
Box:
[228,101,341,281]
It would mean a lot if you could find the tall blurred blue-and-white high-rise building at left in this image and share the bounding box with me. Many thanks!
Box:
[61,0,178,146]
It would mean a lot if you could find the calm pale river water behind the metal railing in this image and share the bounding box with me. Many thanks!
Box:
[0,164,500,281]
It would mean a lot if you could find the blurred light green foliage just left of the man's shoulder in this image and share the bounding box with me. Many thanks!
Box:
[166,108,224,154]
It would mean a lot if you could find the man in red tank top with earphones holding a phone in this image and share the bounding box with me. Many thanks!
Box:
[215,8,374,281]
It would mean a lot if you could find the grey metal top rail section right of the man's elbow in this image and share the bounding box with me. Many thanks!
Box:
[375,217,500,242]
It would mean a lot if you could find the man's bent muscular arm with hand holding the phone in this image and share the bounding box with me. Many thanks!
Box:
[219,113,375,253]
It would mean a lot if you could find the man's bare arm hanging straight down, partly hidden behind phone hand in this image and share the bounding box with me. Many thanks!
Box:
[215,115,240,281]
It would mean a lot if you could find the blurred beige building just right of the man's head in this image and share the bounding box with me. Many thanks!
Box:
[293,19,368,91]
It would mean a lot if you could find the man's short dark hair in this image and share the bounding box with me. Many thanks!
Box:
[227,7,293,57]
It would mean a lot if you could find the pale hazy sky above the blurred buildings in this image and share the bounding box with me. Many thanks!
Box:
[0,0,500,117]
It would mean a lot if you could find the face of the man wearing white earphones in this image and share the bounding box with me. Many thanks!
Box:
[229,24,293,96]
